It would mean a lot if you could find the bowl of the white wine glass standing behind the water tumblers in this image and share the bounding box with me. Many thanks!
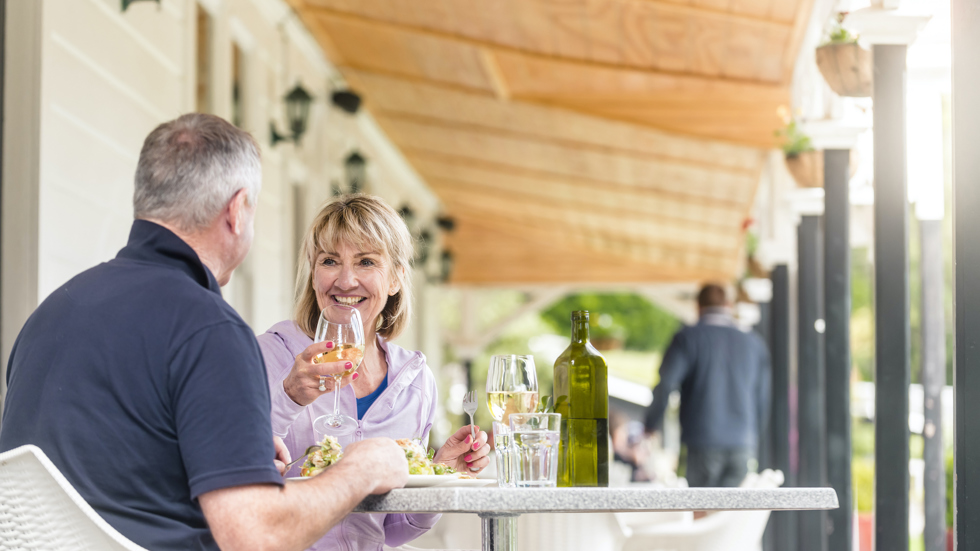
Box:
[487,354,538,423]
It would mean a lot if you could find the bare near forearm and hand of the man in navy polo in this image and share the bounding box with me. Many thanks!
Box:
[199,438,408,551]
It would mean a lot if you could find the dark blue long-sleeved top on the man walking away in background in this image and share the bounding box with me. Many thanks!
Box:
[646,309,771,452]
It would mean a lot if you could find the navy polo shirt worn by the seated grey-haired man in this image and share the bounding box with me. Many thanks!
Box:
[0,220,282,550]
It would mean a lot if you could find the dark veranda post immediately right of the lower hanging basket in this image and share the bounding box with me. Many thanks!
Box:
[824,149,853,551]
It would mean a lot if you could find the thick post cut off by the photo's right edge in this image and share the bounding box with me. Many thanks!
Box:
[951,0,980,550]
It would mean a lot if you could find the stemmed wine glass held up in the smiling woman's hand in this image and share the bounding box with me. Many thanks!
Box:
[313,304,364,436]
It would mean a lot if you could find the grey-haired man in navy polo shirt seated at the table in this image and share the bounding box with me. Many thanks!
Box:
[0,114,408,550]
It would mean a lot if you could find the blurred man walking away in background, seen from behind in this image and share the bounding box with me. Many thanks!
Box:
[646,284,771,487]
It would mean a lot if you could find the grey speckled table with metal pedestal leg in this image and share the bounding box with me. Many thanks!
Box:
[354,487,838,551]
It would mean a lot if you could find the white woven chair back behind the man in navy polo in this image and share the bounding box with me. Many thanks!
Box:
[0,446,145,551]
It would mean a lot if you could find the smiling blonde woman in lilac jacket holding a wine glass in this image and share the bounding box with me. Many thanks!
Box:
[258,194,490,550]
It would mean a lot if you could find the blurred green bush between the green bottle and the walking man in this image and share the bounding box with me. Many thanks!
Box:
[541,293,680,353]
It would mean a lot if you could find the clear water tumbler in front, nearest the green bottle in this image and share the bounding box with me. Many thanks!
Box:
[510,413,561,488]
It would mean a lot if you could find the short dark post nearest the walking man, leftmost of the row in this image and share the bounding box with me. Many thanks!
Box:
[766,264,797,551]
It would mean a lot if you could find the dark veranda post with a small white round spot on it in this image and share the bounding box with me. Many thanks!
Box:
[797,216,827,551]
